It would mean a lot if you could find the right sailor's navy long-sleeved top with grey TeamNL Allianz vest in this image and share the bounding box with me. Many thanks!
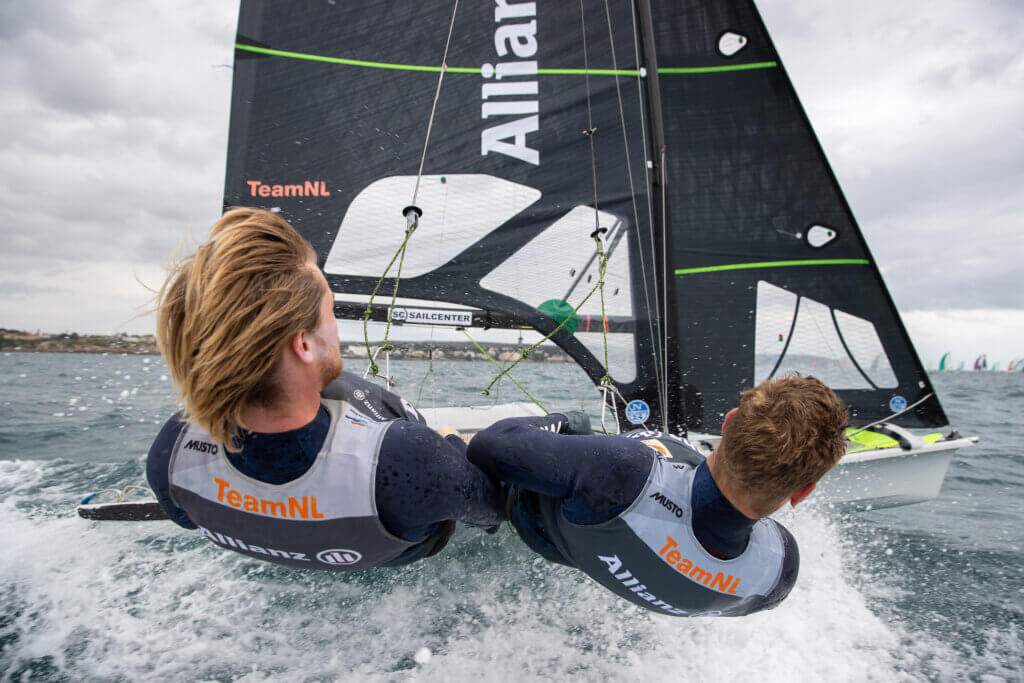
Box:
[468,415,800,616]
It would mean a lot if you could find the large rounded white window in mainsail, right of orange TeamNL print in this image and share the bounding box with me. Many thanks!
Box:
[324,174,541,278]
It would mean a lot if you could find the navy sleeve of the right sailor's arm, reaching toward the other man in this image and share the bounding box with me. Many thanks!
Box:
[467,414,654,524]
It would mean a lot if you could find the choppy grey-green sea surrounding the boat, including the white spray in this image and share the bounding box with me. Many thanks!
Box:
[0,353,1024,681]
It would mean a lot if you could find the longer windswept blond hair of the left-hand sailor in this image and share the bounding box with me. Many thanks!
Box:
[157,208,325,451]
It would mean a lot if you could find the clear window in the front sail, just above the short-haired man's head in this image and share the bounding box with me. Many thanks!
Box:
[755,281,897,389]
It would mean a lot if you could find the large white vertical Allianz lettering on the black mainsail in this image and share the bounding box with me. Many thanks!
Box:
[480,0,541,166]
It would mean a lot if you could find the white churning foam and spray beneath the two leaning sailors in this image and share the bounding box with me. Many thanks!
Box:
[0,462,958,681]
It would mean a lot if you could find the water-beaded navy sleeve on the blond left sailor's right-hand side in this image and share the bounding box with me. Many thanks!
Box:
[375,421,505,541]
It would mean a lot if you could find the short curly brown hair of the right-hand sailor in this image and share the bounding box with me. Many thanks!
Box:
[720,375,849,507]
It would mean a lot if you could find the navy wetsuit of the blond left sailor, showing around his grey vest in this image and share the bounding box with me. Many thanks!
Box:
[146,373,505,565]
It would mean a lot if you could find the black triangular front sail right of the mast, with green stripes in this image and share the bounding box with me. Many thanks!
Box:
[649,0,946,431]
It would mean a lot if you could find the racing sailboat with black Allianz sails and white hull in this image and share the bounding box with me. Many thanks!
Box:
[224,0,971,507]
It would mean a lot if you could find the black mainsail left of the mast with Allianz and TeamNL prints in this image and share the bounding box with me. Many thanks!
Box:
[224,0,665,422]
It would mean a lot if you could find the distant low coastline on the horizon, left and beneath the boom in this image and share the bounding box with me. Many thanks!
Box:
[0,328,570,362]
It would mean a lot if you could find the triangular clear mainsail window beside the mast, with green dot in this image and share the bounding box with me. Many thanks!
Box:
[480,206,636,382]
